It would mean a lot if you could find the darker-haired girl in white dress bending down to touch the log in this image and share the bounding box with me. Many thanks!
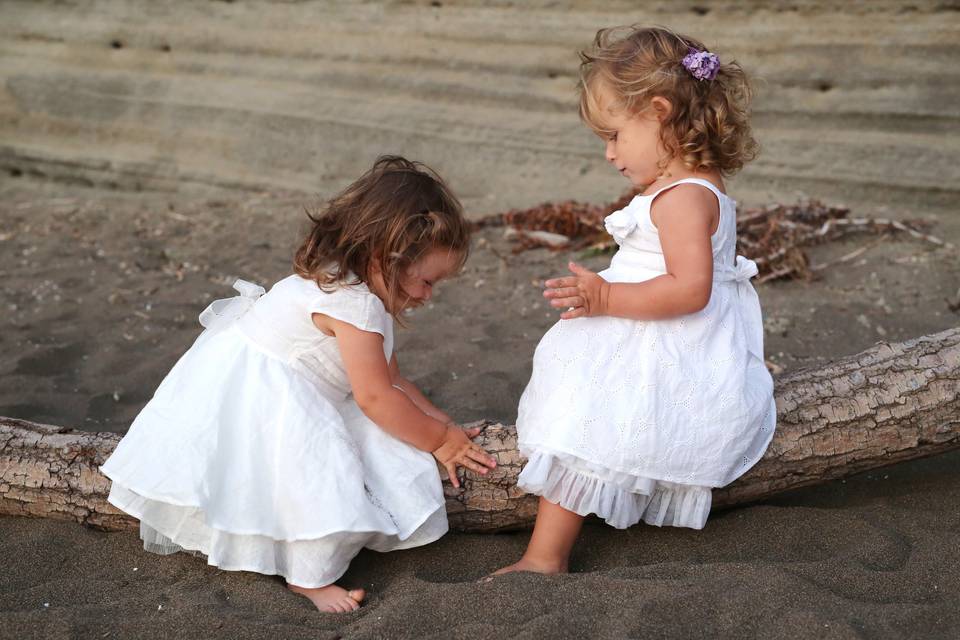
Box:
[101,157,495,611]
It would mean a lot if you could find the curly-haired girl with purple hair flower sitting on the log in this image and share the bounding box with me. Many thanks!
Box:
[497,27,776,573]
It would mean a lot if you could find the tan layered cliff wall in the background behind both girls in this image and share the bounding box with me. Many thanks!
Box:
[0,0,960,213]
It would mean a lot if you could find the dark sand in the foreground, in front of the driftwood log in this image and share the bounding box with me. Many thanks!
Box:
[0,440,960,639]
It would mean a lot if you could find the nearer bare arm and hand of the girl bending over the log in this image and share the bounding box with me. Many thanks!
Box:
[313,313,496,487]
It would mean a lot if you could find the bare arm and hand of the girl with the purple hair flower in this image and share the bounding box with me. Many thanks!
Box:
[543,185,719,320]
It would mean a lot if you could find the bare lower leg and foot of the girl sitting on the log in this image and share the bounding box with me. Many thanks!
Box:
[493,497,583,575]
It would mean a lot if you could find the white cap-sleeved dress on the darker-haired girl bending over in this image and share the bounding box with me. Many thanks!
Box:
[101,276,447,587]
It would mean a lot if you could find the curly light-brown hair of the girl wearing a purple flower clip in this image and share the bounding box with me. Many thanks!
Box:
[579,25,758,176]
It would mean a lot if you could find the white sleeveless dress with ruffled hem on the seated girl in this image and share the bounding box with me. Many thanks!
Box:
[517,178,776,529]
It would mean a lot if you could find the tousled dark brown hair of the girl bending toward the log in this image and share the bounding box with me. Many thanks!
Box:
[293,156,470,318]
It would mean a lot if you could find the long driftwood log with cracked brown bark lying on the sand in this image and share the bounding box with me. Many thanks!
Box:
[0,328,960,532]
